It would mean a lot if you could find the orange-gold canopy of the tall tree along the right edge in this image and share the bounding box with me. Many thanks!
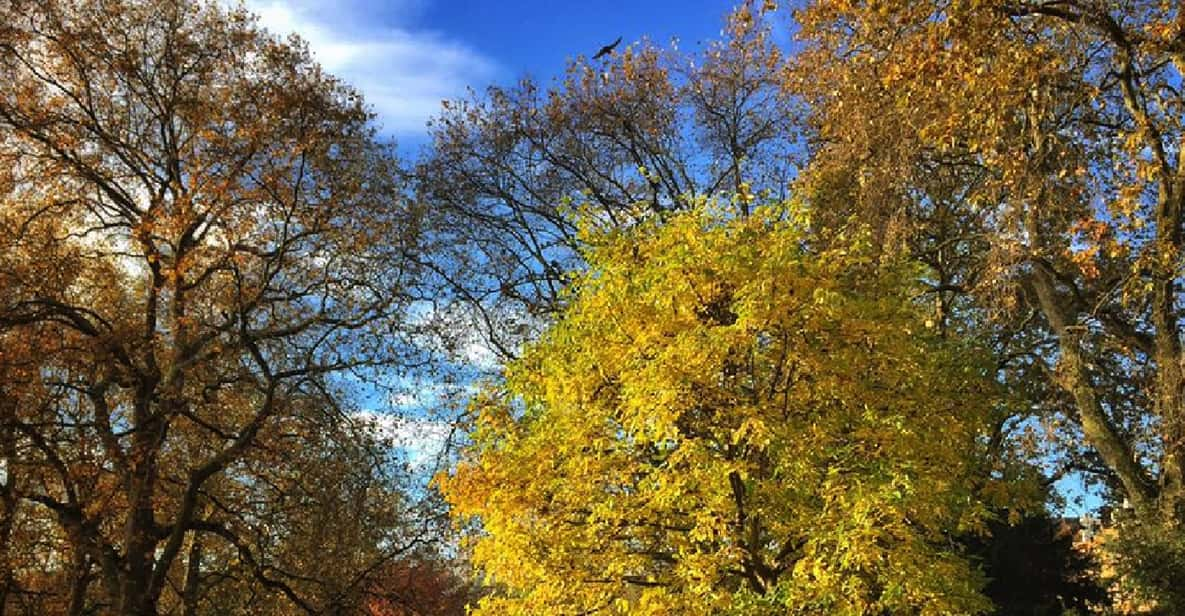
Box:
[790,0,1185,520]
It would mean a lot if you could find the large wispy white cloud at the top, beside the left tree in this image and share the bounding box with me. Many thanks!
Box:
[246,0,500,136]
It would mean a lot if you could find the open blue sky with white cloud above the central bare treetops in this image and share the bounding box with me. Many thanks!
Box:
[245,0,734,147]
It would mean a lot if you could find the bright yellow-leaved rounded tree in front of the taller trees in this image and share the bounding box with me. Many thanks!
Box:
[438,206,999,615]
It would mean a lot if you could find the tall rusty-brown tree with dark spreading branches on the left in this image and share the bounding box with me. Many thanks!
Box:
[0,0,428,615]
